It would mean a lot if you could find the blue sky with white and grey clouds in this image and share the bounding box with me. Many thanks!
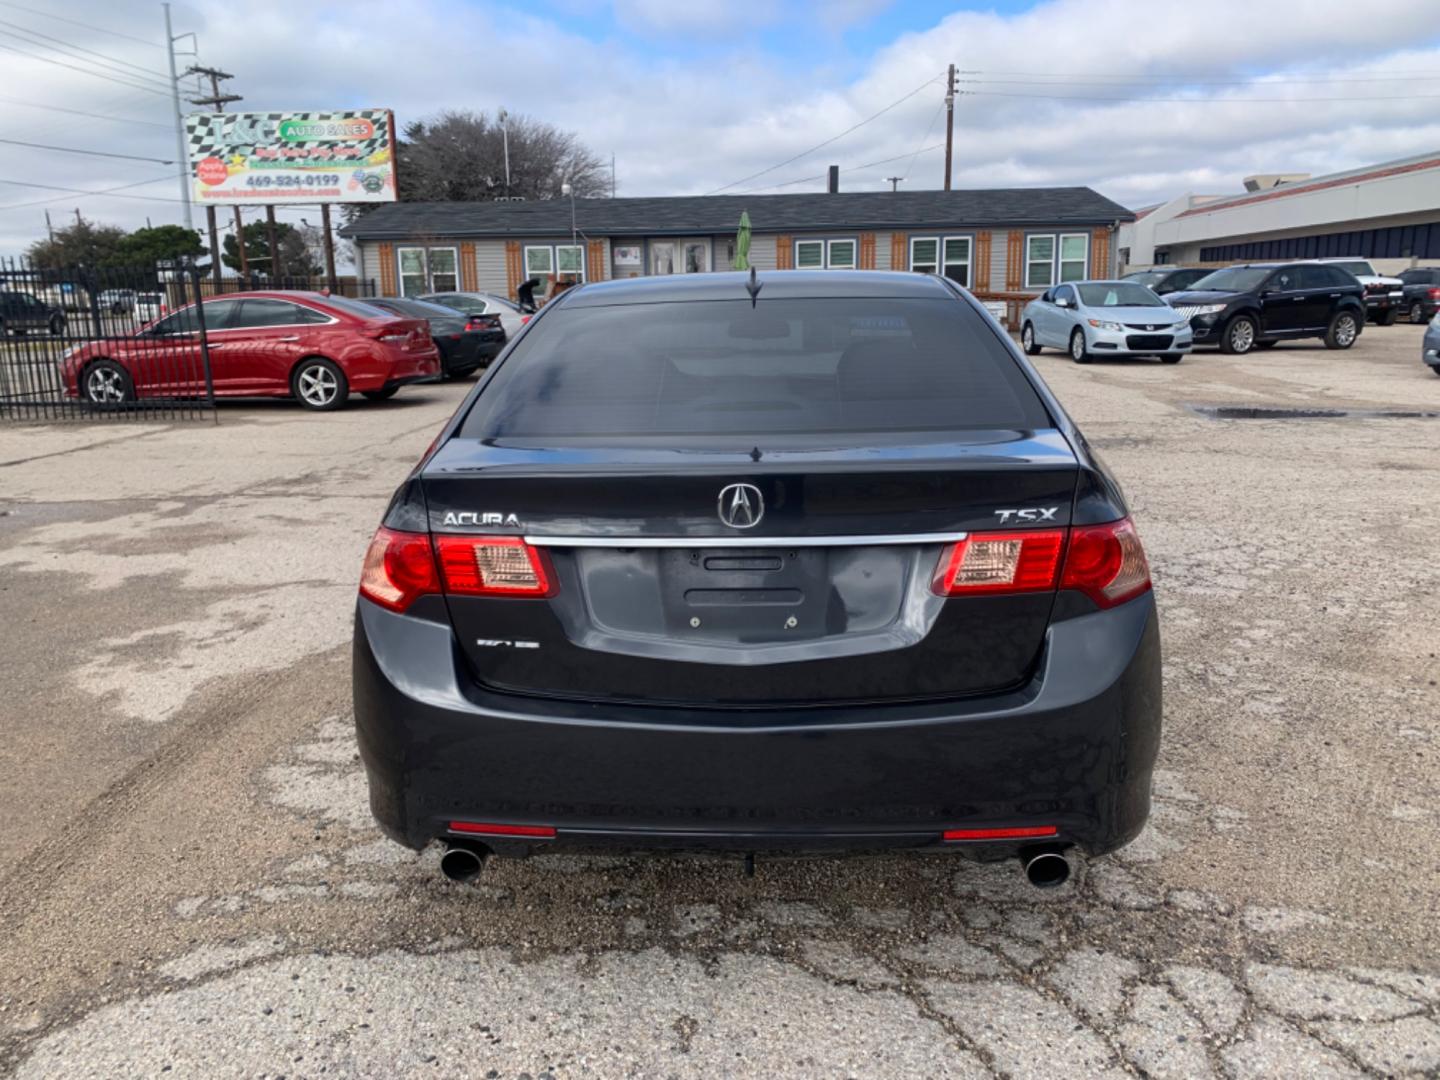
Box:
[0,0,1440,255]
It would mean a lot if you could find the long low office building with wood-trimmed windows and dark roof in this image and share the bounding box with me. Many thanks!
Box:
[340,187,1133,325]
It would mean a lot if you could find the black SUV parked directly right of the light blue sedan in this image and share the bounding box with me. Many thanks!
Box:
[1165,262,1365,353]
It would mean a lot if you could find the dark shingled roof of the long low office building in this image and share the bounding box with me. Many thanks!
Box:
[340,187,1135,240]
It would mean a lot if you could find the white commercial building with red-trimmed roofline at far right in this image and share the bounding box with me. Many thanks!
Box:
[1119,151,1440,274]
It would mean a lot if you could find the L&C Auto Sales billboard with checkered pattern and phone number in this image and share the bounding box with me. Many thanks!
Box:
[184,109,396,204]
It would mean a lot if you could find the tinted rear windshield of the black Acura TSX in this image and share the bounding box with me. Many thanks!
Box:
[461,298,1051,445]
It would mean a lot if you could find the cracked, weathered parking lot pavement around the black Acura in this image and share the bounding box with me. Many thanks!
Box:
[0,325,1440,1079]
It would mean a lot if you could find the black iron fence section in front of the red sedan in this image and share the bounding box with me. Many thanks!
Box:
[0,259,215,420]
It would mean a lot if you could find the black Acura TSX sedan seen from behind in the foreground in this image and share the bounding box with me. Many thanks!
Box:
[353,271,1161,884]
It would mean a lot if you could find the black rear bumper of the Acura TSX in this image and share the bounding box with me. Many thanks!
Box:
[353,593,1161,857]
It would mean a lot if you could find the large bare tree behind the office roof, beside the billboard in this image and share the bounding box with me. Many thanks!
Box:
[396,111,609,203]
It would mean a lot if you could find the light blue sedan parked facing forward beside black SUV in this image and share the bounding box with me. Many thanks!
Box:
[1020,281,1191,364]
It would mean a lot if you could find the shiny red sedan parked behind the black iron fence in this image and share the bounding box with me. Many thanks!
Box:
[62,292,441,409]
